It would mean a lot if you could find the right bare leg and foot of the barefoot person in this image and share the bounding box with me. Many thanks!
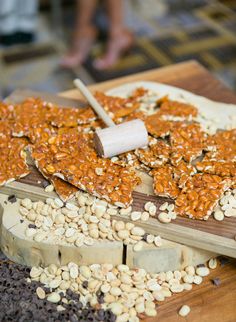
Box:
[94,0,133,69]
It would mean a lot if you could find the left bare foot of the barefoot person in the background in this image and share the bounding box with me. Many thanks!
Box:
[61,27,97,68]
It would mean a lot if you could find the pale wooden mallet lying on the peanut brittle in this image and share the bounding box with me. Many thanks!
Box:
[74,79,148,158]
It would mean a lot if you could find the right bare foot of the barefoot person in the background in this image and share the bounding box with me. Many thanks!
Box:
[93,30,134,70]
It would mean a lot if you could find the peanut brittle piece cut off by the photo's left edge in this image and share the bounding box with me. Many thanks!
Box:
[0,136,30,186]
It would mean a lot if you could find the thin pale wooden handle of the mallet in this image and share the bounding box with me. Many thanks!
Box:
[74,78,115,127]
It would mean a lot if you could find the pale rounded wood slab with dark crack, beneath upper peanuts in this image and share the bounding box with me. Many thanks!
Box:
[0,194,217,273]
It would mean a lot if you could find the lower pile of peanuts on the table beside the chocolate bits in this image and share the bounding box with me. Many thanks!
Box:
[28,259,217,322]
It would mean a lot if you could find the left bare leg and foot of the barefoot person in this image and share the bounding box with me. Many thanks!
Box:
[61,0,97,68]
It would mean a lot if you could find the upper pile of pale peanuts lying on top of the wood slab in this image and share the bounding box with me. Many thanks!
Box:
[19,192,162,251]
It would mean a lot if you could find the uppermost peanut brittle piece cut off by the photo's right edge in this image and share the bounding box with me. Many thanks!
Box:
[206,129,236,161]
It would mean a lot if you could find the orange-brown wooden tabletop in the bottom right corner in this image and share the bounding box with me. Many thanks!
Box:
[145,260,236,322]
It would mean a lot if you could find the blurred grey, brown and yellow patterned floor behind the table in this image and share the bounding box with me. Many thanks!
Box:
[0,0,236,96]
